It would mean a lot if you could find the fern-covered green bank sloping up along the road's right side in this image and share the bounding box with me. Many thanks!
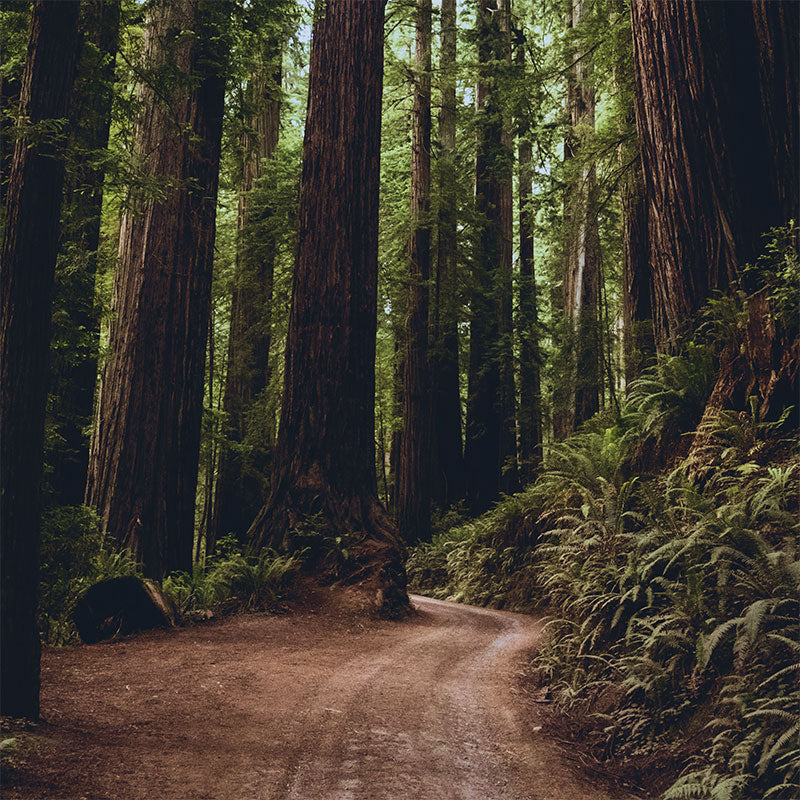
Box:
[408,364,800,800]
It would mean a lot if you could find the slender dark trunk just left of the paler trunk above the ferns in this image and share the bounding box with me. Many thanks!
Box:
[517,43,542,483]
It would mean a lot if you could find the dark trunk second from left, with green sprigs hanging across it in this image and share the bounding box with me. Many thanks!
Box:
[48,0,120,506]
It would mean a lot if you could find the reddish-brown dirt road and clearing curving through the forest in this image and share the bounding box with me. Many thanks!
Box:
[2,597,644,800]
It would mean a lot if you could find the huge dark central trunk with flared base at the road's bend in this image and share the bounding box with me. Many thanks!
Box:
[250,0,408,612]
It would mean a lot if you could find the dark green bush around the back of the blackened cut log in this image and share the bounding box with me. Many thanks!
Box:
[39,506,139,645]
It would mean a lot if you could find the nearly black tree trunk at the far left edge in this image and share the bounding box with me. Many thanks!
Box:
[0,0,78,720]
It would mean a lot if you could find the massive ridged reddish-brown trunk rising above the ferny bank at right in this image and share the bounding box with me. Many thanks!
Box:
[631,0,798,350]
